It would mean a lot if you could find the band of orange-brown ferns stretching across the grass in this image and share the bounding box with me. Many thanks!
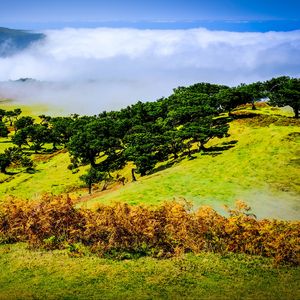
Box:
[0,196,300,265]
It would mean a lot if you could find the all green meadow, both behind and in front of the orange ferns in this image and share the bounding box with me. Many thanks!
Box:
[0,104,300,299]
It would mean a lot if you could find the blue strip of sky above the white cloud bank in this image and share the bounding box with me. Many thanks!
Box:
[0,0,300,31]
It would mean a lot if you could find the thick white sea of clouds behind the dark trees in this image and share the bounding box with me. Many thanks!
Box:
[0,28,300,114]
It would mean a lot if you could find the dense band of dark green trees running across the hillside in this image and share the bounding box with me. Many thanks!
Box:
[0,77,300,189]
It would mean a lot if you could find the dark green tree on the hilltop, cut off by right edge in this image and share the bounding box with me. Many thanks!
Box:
[270,78,300,119]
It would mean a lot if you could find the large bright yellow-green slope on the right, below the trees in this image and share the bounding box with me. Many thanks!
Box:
[89,115,300,219]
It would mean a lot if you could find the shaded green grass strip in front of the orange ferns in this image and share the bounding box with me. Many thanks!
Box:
[0,244,300,299]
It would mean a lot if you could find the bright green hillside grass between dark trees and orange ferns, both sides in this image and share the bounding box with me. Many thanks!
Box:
[0,103,300,219]
